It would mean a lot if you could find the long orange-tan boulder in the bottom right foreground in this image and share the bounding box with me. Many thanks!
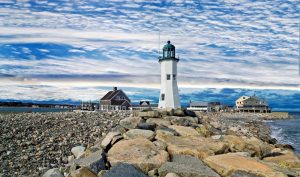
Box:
[204,153,287,177]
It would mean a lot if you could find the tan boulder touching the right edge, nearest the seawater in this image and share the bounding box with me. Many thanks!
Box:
[263,150,300,169]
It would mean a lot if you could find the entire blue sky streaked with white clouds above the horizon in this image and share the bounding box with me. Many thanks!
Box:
[0,0,300,111]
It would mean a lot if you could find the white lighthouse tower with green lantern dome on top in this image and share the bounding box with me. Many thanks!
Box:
[158,41,180,109]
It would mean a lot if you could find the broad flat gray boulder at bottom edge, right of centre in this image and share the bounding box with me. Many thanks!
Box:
[158,155,220,177]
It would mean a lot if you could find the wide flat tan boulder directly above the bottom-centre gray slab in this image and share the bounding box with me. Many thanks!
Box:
[155,135,228,159]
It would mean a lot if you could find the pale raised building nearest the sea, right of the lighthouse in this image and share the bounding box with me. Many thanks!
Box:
[235,95,271,113]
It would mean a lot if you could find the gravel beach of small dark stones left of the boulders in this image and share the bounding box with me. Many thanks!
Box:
[0,112,129,176]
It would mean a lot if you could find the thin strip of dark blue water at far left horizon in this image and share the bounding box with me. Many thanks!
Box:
[0,107,68,113]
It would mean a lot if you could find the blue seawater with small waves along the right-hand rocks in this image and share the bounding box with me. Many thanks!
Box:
[267,112,300,154]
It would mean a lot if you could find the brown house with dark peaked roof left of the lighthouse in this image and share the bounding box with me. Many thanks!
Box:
[100,87,131,111]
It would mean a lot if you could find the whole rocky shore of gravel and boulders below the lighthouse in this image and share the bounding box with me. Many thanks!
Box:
[0,110,300,177]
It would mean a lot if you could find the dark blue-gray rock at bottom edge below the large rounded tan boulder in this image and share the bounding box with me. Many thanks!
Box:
[103,163,147,177]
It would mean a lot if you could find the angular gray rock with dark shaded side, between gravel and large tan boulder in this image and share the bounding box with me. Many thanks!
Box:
[75,149,106,174]
